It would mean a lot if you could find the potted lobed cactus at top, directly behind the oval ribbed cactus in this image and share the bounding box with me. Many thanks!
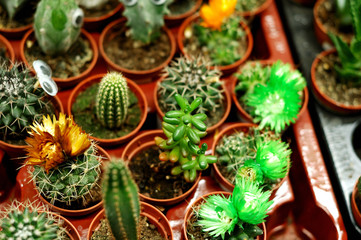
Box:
[99,0,176,81]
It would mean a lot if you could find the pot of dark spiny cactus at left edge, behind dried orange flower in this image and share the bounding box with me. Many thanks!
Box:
[0,96,64,158]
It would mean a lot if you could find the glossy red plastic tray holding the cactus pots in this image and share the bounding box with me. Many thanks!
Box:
[0,2,347,240]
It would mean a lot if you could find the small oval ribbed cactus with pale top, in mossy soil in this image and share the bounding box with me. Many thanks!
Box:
[95,72,129,129]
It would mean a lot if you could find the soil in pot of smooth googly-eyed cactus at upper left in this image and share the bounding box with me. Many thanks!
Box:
[24,34,93,79]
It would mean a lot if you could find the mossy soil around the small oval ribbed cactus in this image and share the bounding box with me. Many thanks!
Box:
[72,83,141,139]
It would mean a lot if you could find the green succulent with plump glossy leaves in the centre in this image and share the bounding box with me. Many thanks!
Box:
[154,94,217,182]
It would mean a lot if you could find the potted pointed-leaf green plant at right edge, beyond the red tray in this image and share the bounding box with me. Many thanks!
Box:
[311,0,361,114]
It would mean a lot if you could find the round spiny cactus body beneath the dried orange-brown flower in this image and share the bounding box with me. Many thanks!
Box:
[31,144,101,207]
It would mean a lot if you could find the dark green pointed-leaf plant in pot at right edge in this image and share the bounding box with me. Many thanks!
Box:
[328,0,361,86]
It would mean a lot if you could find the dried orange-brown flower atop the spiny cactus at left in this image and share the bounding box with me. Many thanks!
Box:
[26,113,91,172]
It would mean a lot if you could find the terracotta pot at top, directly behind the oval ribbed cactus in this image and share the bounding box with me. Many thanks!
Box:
[99,18,176,82]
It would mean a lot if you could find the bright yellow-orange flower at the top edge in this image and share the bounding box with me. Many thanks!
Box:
[200,0,237,30]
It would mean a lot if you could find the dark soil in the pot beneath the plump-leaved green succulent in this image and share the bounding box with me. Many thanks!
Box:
[128,145,194,199]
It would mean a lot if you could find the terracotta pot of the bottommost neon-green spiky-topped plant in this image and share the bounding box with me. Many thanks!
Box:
[182,192,267,240]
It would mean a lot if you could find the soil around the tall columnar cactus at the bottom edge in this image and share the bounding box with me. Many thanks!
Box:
[91,216,164,240]
